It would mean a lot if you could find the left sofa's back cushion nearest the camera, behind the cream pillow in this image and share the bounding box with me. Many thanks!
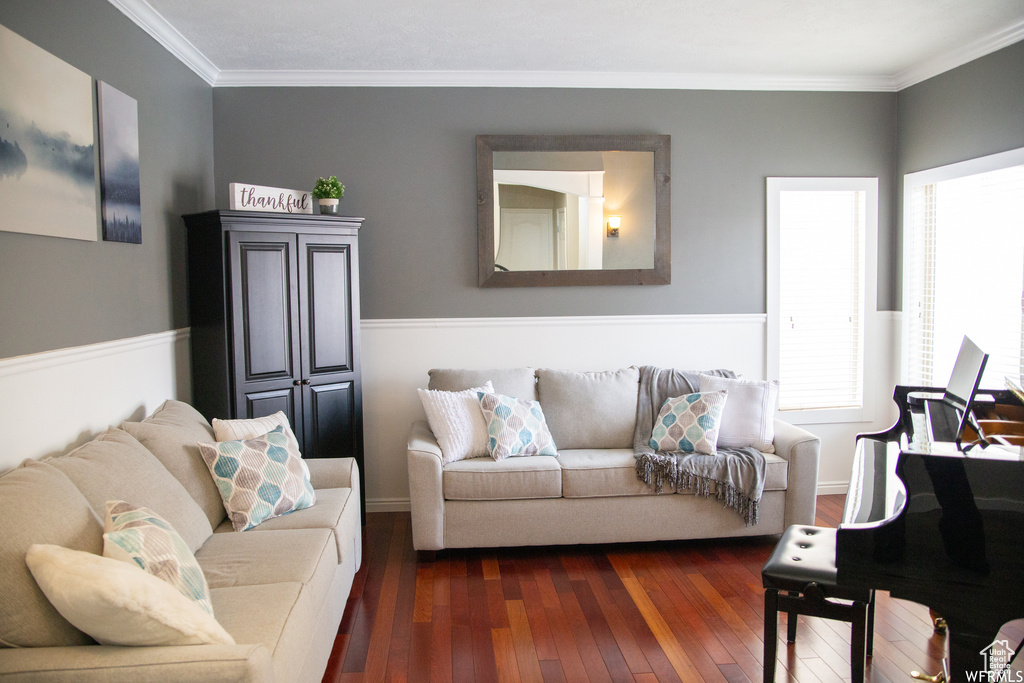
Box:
[0,461,103,647]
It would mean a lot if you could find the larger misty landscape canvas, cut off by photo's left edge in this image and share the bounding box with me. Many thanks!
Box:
[0,26,97,241]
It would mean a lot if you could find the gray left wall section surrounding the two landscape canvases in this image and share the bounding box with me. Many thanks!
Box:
[0,0,213,358]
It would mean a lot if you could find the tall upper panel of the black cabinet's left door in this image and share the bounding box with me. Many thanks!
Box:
[230,232,298,384]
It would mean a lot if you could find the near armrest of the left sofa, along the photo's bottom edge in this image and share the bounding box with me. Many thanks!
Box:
[0,645,273,683]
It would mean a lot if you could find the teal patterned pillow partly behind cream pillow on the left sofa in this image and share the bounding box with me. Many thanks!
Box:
[103,501,213,616]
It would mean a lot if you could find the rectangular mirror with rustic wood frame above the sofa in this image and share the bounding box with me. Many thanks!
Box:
[476,135,672,287]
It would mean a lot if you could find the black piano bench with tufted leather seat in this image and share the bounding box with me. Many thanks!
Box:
[761,524,874,683]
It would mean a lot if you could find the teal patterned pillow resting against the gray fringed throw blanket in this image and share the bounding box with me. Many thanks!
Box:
[648,391,726,456]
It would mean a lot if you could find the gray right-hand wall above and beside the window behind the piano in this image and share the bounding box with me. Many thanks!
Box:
[893,42,1024,309]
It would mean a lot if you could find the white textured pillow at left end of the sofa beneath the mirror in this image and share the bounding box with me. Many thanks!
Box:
[416,381,495,465]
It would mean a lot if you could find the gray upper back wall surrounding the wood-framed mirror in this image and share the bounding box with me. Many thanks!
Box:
[213,88,896,318]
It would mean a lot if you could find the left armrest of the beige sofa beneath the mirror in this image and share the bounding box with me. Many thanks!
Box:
[407,422,444,550]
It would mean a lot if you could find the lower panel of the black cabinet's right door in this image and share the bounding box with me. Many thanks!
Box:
[302,382,361,458]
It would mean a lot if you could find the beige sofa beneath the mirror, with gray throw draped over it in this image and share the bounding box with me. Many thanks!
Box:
[408,368,820,552]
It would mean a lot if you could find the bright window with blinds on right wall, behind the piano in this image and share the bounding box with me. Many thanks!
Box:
[901,150,1024,388]
